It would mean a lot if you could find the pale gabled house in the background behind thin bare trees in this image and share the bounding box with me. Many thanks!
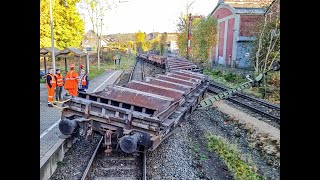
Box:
[81,30,107,52]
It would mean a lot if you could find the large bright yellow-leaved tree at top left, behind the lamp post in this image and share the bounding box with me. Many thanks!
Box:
[40,0,84,49]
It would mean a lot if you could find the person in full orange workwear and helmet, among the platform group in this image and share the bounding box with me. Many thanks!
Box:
[64,64,78,96]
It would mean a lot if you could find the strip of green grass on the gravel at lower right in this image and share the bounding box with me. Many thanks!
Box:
[206,134,264,180]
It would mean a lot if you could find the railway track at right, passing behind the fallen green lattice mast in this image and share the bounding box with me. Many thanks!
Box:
[208,82,280,124]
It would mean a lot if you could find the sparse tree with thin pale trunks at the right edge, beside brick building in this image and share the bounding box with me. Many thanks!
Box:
[251,0,280,98]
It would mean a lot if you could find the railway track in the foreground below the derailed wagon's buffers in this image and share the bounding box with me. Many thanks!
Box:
[81,138,147,180]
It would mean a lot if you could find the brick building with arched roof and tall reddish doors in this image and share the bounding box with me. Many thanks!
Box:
[210,0,272,68]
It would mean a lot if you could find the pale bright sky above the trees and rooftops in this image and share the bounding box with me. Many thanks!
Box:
[79,0,218,35]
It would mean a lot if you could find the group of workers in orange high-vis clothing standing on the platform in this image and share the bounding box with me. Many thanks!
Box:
[46,64,89,107]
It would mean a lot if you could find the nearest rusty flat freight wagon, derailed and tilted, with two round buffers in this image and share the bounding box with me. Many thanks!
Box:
[59,69,209,153]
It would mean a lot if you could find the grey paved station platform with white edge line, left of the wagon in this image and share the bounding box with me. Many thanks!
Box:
[40,70,123,179]
